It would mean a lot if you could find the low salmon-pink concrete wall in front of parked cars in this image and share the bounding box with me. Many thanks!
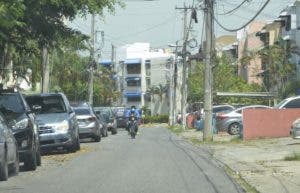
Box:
[243,109,300,140]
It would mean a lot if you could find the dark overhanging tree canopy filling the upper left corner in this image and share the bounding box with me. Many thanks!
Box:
[0,0,123,84]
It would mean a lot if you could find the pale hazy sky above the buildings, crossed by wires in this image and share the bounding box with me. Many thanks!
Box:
[69,0,295,59]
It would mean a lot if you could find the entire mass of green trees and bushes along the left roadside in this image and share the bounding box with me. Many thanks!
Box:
[0,0,124,105]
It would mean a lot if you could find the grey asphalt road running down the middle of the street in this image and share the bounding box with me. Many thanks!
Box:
[0,127,243,193]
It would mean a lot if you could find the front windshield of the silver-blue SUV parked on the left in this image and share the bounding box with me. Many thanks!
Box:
[26,96,67,114]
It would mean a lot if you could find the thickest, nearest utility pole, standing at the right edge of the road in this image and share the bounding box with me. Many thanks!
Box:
[203,0,214,141]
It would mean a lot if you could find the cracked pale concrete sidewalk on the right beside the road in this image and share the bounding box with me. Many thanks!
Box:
[180,130,300,193]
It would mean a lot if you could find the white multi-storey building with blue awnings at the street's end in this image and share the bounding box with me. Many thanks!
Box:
[109,43,174,115]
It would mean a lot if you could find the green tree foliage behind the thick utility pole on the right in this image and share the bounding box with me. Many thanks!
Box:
[188,57,265,104]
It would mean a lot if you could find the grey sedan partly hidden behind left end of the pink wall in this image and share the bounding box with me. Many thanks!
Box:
[216,105,272,135]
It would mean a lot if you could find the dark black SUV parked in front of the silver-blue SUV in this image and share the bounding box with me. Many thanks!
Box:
[0,90,41,170]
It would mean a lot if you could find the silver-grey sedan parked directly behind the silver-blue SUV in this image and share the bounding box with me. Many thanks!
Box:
[74,105,101,142]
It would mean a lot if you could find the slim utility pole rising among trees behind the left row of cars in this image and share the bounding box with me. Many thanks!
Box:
[88,13,95,105]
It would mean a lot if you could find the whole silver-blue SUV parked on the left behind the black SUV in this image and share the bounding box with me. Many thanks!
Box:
[26,93,80,152]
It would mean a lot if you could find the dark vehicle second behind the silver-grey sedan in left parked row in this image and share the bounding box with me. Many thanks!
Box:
[94,107,118,134]
